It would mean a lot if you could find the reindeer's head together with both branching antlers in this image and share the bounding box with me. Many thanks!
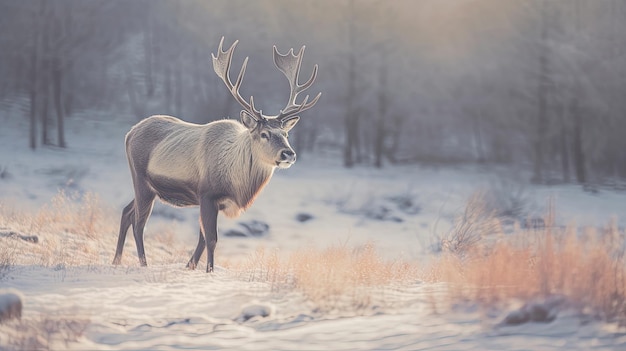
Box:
[212,37,322,168]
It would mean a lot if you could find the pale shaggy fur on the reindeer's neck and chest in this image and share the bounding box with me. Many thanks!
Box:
[218,124,276,217]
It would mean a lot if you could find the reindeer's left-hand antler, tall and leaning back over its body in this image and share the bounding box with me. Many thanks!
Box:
[211,37,265,121]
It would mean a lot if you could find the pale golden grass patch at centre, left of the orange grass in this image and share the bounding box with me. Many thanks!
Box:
[231,244,417,311]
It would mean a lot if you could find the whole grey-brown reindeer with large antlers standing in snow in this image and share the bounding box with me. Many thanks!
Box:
[113,37,321,273]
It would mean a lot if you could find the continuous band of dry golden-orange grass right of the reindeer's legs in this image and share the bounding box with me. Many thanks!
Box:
[218,193,626,324]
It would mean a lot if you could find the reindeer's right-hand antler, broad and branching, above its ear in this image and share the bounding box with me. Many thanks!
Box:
[274,45,322,121]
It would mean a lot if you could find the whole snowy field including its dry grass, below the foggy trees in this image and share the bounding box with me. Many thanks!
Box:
[0,120,626,350]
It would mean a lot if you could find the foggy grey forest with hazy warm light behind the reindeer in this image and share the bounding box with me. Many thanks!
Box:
[0,0,626,184]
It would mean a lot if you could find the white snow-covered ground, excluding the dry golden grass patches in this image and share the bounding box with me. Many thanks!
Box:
[0,115,626,350]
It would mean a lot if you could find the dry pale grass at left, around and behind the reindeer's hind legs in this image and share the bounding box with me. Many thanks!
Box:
[0,192,188,268]
